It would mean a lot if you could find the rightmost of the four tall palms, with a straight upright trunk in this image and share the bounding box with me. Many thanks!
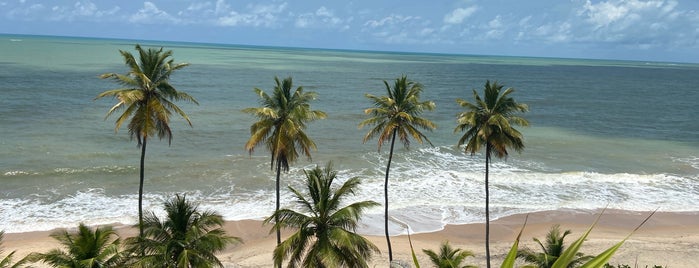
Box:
[454,81,529,268]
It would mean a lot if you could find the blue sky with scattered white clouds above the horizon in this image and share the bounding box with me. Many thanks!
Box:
[0,0,699,63]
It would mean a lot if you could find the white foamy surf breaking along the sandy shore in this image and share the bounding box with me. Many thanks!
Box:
[0,148,699,234]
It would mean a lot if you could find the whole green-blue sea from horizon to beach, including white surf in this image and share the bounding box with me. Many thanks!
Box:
[0,35,699,234]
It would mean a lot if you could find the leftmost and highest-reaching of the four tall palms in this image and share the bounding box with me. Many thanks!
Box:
[95,45,199,237]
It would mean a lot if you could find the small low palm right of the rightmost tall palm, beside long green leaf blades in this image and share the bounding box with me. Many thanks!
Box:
[517,225,593,268]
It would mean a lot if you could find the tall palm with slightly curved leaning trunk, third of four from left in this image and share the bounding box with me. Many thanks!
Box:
[359,75,436,262]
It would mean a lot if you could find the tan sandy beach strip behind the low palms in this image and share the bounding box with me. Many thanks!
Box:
[3,210,699,268]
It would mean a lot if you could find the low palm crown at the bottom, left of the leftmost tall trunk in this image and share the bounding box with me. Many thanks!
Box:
[30,223,123,268]
